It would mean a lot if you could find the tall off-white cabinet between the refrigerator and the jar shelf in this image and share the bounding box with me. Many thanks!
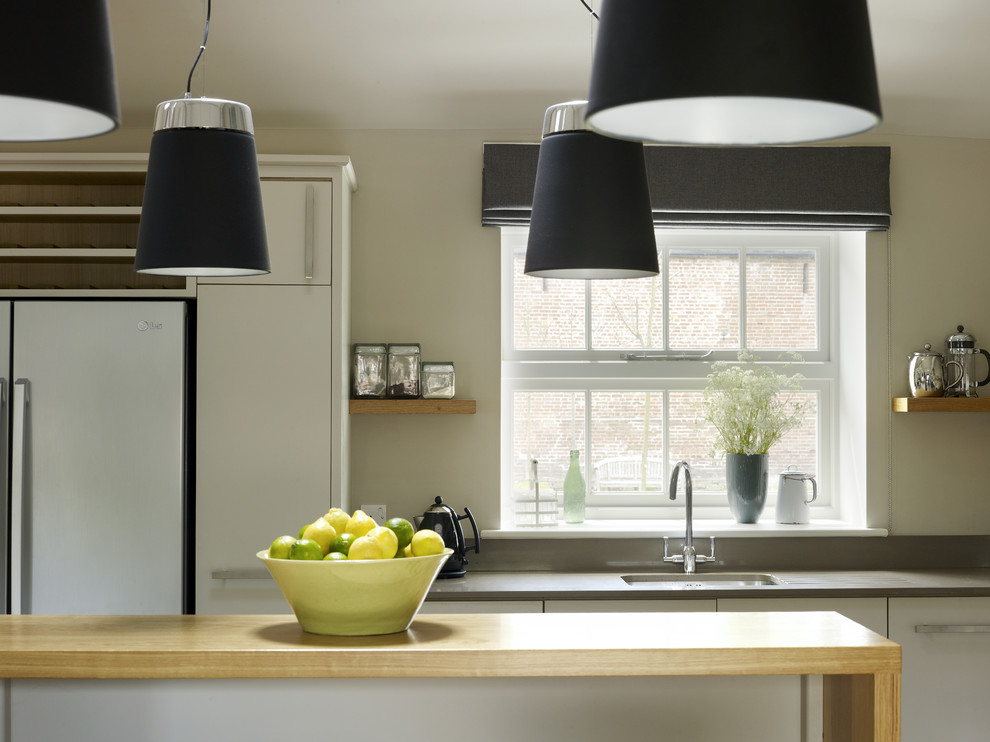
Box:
[196,158,353,613]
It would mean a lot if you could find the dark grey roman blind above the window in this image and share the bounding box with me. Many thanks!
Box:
[481,144,890,230]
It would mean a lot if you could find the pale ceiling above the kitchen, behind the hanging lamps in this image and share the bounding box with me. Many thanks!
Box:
[110,0,990,139]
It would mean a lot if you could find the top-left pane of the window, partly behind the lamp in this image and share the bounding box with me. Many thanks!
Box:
[512,251,585,350]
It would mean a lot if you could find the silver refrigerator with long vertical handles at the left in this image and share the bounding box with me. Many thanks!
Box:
[0,300,191,614]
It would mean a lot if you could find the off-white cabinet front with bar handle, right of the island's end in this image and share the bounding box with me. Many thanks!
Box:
[889,598,990,742]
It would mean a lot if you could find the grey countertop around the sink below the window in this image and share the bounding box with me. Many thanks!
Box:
[427,568,990,600]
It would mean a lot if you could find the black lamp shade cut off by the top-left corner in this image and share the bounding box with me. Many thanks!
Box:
[0,0,120,142]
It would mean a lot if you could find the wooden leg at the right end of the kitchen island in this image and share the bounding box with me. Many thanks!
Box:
[823,672,901,742]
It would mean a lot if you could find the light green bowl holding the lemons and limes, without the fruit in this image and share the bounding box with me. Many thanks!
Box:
[258,549,454,636]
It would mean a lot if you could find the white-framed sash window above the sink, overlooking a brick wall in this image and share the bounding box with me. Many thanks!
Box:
[502,227,838,527]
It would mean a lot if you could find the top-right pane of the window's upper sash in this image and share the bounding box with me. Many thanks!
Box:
[746,250,818,350]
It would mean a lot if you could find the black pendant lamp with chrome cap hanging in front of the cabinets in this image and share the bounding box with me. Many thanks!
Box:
[134,98,271,276]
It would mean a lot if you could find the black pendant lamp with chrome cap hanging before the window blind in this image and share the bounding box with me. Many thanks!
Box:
[524,101,659,279]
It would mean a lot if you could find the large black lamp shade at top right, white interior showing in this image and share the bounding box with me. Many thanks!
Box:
[588,0,881,145]
